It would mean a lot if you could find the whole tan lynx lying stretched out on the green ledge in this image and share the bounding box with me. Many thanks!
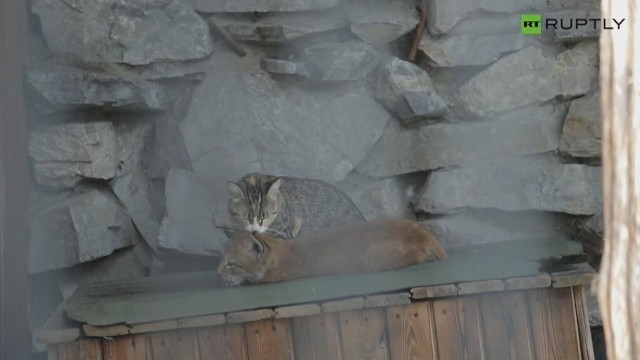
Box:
[218,219,447,286]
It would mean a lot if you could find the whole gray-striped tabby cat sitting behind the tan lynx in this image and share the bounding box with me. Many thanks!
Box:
[227,173,364,239]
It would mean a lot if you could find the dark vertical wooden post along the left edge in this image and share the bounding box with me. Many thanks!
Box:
[0,0,29,360]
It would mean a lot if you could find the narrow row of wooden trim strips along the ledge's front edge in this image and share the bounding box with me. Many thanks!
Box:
[38,264,595,344]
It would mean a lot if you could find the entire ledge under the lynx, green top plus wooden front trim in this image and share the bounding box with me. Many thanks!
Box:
[35,239,595,343]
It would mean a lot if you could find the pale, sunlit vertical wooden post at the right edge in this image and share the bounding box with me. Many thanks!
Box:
[598,0,640,360]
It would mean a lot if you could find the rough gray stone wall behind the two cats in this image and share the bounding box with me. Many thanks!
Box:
[25,0,602,354]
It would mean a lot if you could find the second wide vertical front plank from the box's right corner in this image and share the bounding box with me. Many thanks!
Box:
[478,291,535,360]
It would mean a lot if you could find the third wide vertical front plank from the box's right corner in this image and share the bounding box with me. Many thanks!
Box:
[433,297,486,360]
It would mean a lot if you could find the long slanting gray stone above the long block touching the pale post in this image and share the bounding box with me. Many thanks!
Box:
[358,105,566,177]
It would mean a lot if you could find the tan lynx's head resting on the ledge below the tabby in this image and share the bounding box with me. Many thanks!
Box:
[218,231,268,286]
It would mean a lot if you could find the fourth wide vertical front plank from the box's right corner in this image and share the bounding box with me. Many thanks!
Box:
[386,302,438,360]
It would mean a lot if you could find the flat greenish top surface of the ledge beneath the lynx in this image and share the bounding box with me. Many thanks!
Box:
[66,238,582,326]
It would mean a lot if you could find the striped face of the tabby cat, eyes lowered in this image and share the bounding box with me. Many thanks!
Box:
[227,177,281,233]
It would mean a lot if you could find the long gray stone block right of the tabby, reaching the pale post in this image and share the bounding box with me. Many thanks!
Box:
[415,158,602,215]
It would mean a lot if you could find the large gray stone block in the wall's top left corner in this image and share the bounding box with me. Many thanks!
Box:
[32,0,212,65]
